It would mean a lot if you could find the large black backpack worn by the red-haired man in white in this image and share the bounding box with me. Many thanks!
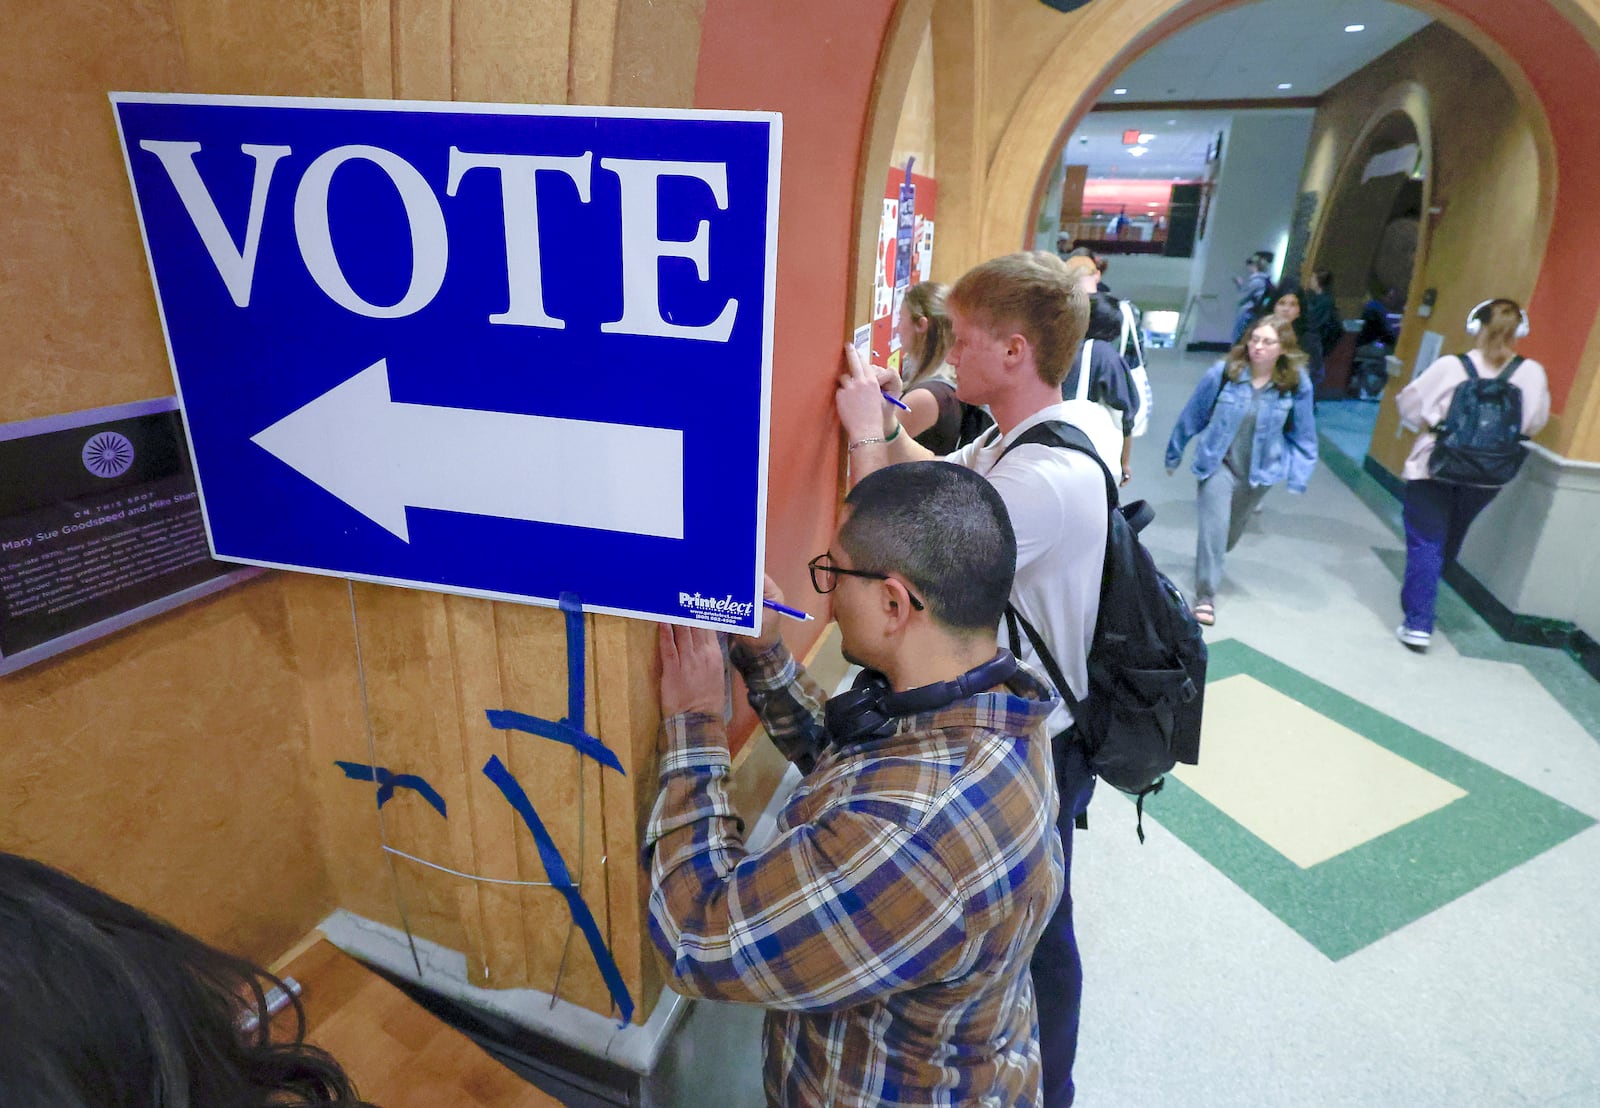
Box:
[1000,420,1206,842]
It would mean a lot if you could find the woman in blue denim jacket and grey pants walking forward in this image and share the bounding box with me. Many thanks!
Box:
[1166,315,1317,624]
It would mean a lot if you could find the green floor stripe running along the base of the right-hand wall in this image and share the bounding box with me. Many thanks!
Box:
[1318,440,1600,743]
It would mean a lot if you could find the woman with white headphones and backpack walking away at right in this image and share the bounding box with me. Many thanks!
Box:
[1395,298,1550,653]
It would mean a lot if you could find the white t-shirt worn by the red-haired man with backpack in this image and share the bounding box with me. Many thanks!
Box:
[946,403,1107,735]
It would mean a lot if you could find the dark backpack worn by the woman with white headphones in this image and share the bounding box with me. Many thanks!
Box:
[1427,354,1526,488]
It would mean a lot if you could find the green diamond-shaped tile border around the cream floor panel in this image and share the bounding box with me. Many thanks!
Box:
[1146,639,1595,961]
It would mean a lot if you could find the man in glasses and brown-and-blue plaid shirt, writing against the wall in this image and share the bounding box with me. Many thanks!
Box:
[645,463,1062,1108]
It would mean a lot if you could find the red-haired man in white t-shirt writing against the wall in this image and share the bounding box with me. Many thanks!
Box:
[834,251,1107,1108]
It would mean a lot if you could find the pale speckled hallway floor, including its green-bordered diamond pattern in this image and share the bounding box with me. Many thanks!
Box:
[1072,351,1600,1108]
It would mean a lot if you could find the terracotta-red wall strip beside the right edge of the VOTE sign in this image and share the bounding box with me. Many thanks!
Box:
[694,0,894,666]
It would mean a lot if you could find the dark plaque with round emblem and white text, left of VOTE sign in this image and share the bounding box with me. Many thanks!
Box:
[0,397,262,674]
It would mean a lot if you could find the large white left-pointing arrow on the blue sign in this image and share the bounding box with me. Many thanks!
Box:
[251,360,683,543]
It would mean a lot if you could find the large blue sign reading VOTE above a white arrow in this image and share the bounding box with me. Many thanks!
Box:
[110,93,781,632]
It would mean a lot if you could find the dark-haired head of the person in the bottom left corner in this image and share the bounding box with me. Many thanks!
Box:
[0,853,363,1108]
